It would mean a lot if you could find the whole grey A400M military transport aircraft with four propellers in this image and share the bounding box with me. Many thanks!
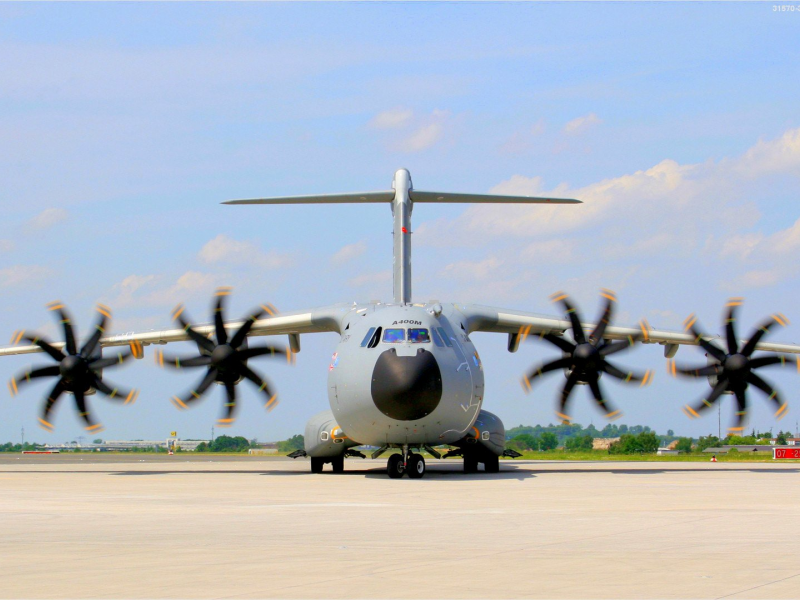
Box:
[0,169,800,478]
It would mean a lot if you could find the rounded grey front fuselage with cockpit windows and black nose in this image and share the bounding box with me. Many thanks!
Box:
[328,303,484,446]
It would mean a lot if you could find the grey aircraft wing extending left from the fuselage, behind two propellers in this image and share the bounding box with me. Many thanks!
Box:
[0,304,353,356]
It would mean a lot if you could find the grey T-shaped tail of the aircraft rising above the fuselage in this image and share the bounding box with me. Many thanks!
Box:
[223,169,581,304]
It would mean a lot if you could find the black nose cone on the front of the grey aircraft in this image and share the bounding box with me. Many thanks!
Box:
[372,348,442,421]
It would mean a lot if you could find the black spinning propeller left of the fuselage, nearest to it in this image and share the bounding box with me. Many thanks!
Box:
[156,288,294,427]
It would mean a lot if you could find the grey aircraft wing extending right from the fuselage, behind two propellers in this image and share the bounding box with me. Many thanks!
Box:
[456,305,800,354]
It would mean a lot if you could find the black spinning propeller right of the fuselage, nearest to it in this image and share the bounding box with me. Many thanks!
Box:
[520,290,653,423]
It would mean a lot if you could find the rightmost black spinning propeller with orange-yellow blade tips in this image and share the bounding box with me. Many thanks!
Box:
[667,298,800,433]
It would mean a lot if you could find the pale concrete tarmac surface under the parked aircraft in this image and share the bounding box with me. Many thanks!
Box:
[0,454,800,598]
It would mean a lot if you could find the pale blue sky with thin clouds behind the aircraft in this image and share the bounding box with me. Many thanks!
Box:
[0,3,800,441]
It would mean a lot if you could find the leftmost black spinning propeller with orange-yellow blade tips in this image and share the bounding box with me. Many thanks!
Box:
[8,302,142,433]
